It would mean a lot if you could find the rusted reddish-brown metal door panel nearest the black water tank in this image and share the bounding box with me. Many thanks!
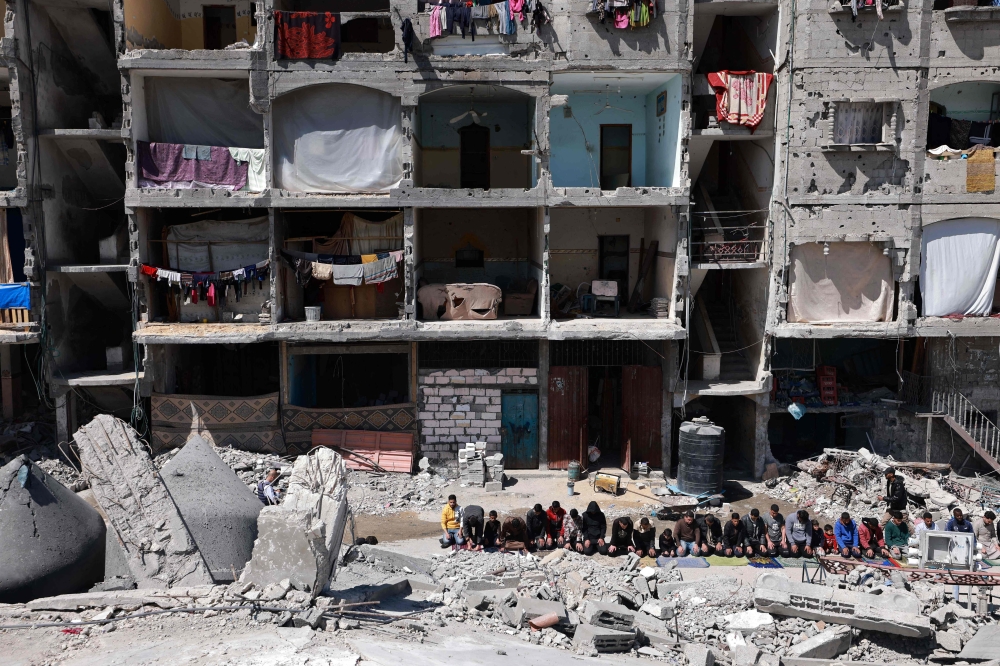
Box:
[622,365,663,467]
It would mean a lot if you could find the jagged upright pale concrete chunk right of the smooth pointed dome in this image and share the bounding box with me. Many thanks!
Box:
[240,448,347,597]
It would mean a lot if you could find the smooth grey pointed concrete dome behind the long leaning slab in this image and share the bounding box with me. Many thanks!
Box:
[160,435,264,583]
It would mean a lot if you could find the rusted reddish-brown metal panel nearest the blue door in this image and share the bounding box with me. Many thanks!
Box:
[548,366,589,469]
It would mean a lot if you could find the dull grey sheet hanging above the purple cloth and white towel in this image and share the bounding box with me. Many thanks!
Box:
[145,76,264,148]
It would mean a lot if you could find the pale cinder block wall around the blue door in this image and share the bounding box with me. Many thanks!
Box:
[417,368,538,469]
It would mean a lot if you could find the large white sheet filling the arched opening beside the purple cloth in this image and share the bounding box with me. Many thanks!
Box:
[273,84,403,193]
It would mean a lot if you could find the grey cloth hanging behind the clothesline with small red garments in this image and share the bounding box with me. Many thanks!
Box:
[166,215,270,273]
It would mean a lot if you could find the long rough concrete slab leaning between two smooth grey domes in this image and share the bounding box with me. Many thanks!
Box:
[73,414,212,588]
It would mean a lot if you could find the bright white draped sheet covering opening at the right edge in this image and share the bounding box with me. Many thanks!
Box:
[920,217,1000,317]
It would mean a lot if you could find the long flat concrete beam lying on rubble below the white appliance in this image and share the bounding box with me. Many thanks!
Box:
[754,573,931,638]
